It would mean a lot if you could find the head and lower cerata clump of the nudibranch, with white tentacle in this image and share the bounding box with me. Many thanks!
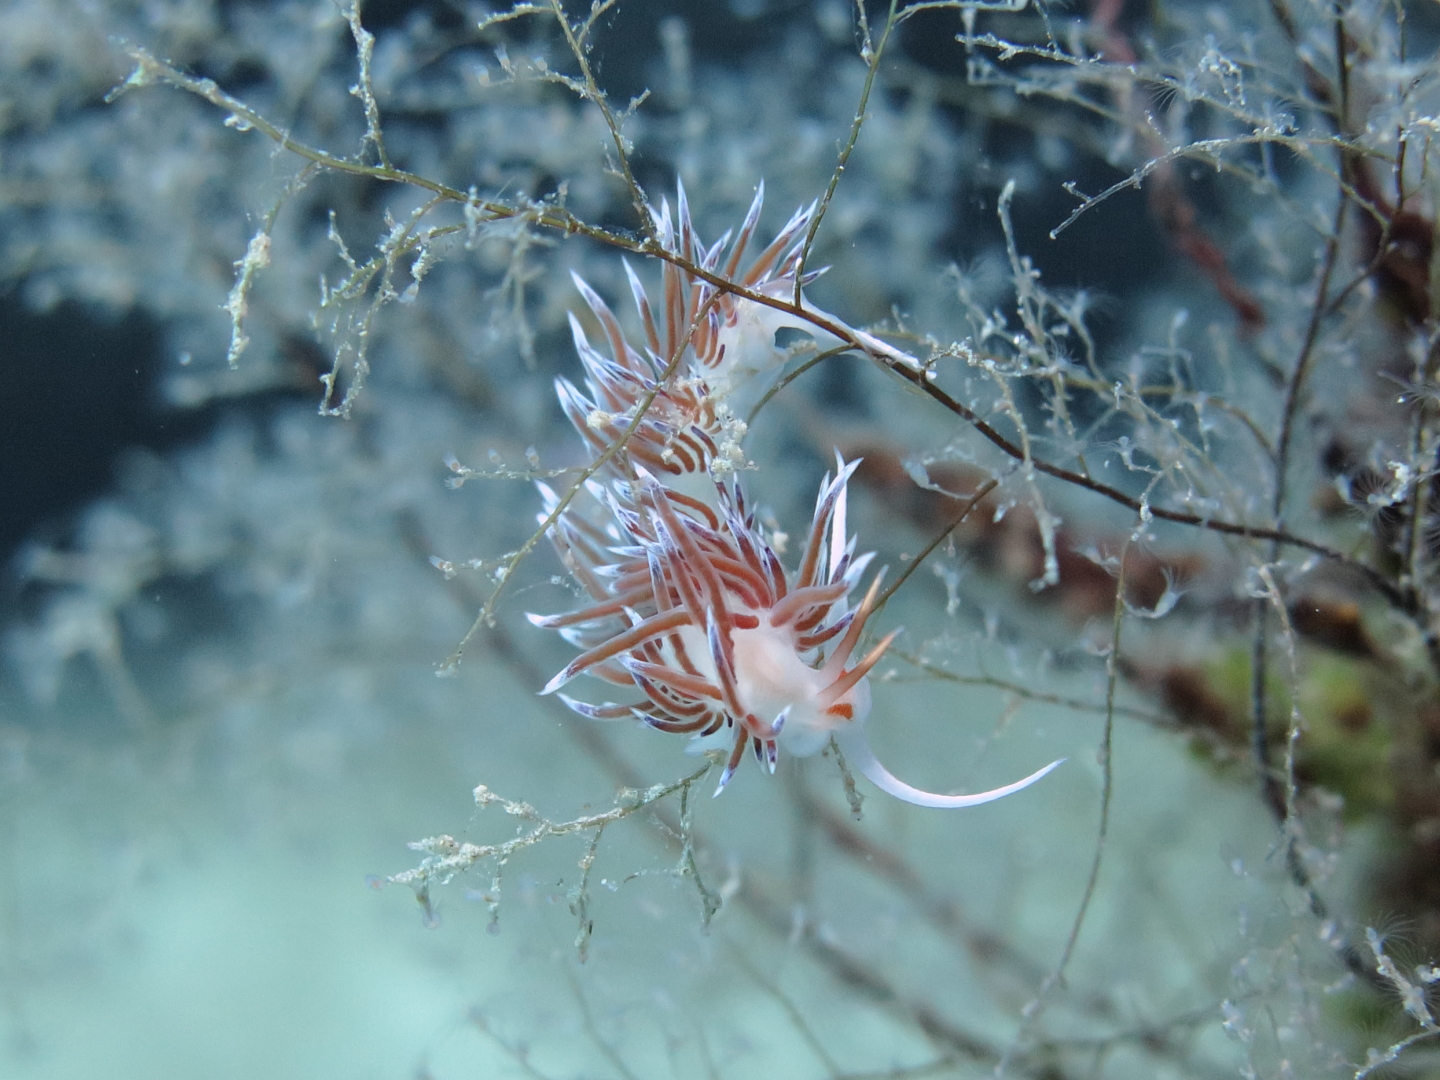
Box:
[530,461,1060,806]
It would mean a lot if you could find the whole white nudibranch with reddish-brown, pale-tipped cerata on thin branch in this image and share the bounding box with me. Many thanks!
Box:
[530,182,1058,806]
